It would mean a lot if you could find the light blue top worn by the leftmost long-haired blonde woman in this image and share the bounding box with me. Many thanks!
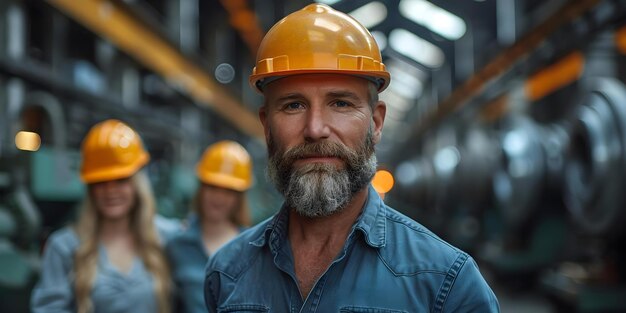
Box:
[30,217,180,313]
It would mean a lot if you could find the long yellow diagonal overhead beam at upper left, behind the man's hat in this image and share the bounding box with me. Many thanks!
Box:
[47,0,265,140]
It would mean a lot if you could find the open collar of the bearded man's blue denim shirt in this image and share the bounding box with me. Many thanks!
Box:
[250,185,387,250]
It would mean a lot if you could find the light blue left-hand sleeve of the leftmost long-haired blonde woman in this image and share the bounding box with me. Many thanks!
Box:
[31,232,74,313]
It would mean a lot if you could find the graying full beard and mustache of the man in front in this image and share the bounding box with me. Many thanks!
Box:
[268,132,377,218]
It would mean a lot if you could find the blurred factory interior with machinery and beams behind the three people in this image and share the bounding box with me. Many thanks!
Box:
[0,0,626,313]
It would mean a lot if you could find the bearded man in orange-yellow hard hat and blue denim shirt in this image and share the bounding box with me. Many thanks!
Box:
[205,4,499,312]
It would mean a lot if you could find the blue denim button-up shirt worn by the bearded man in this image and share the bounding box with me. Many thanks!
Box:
[204,186,499,313]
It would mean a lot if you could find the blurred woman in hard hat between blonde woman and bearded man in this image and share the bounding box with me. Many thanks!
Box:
[167,141,252,312]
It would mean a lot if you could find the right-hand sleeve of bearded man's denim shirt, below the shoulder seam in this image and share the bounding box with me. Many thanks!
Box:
[444,257,500,313]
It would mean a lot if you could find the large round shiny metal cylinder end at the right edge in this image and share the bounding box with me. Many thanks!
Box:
[563,78,626,234]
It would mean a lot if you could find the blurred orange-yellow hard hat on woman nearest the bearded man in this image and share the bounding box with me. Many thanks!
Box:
[196,140,252,191]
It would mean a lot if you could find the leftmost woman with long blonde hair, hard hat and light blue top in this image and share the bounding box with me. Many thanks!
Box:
[31,120,171,313]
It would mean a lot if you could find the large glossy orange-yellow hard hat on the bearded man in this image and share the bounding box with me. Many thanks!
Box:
[250,4,390,92]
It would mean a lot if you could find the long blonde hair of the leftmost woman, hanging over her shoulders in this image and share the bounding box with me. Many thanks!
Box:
[74,172,171,313]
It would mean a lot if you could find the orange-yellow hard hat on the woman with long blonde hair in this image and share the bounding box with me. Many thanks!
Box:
[80,120,150,184]
